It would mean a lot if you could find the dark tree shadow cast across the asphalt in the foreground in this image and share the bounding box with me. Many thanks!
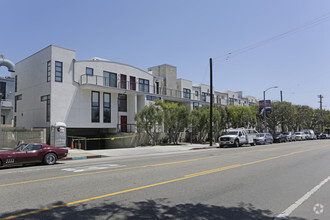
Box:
[0,199,304,220]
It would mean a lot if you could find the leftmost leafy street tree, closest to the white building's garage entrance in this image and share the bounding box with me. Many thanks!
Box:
[134,104,163,145]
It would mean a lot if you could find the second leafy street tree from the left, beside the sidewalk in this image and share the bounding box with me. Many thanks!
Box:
[156,101,190,144]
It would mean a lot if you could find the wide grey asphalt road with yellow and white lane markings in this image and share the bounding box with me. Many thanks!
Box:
[0,140,330,220]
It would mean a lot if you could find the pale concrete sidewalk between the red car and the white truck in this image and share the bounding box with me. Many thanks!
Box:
[63,144,217,160]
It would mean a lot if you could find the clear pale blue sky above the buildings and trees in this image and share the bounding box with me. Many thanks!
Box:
[0,0,330,109]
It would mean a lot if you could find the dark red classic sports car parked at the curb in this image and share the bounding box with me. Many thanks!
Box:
[0,143,68,166]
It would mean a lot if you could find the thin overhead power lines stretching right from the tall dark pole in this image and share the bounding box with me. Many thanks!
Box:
[213,13,330,61]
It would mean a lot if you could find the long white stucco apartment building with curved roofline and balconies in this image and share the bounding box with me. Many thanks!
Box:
[13,45,258,147]
